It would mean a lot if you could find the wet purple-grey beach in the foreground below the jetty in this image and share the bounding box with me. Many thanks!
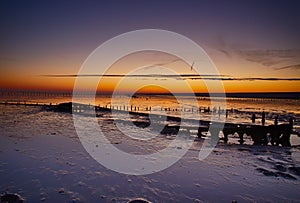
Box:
[0,102,300,202]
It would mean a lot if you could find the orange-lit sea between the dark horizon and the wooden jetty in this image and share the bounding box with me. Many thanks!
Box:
[0,92,300,133]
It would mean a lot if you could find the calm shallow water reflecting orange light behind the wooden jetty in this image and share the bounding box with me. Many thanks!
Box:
[0,95,300,131]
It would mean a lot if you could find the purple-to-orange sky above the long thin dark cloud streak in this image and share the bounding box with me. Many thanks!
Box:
[0,0,300,91]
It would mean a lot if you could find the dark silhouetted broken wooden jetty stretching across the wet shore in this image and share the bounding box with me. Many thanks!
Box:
[0,101,299,146]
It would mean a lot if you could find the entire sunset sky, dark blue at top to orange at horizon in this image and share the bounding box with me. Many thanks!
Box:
[0,0,300,92]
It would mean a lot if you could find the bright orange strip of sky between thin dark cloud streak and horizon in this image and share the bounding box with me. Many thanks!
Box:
[0,77,300,94]
